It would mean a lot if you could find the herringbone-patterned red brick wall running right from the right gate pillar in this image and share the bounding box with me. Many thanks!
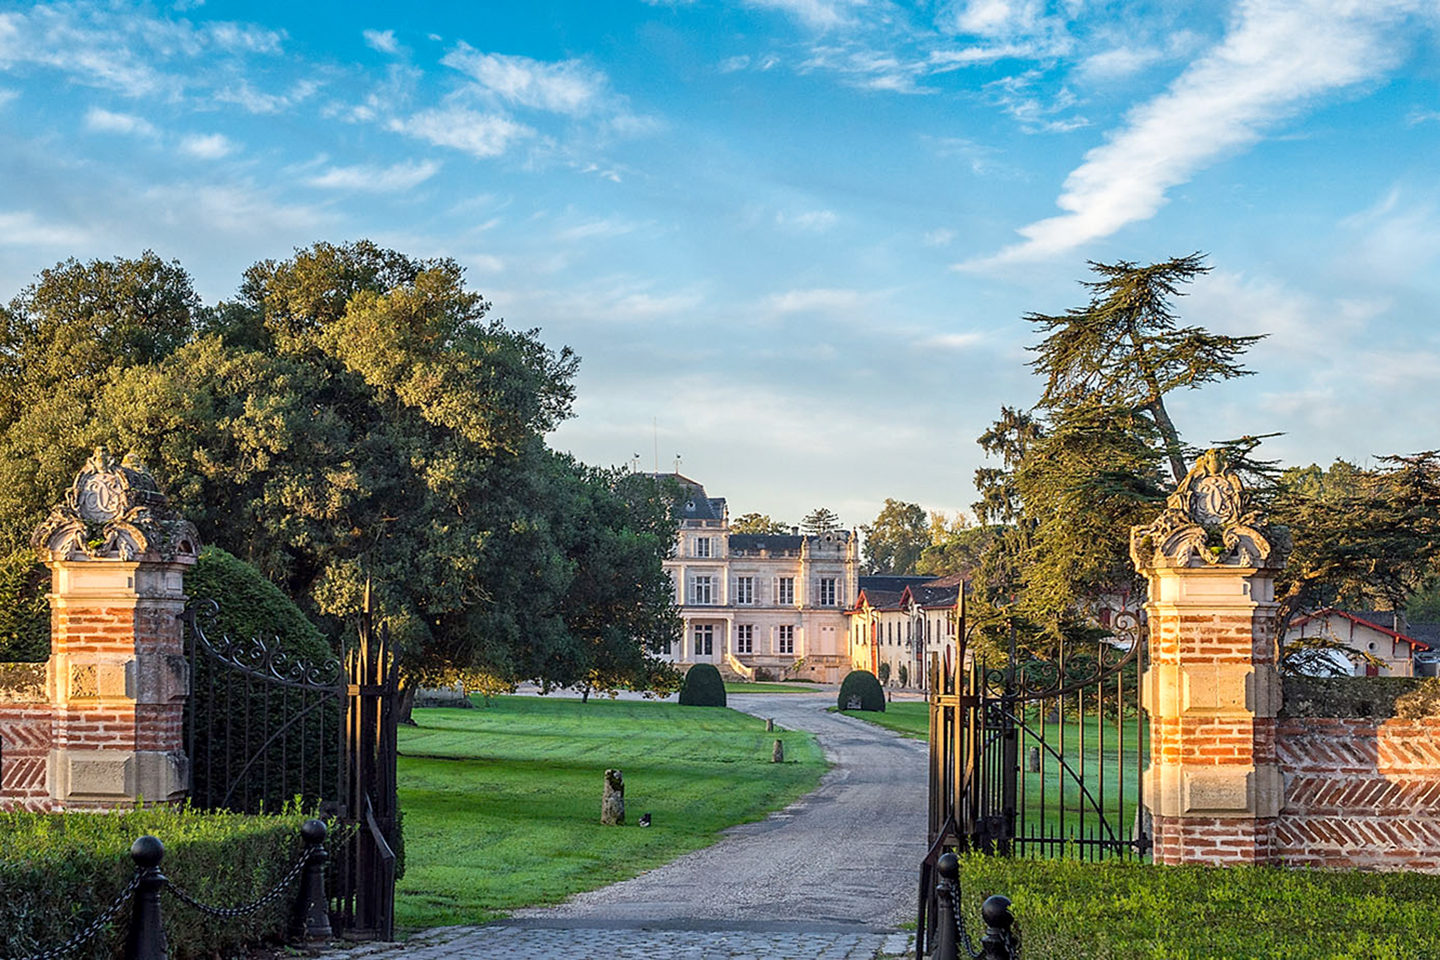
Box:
[1272,717,1440,872]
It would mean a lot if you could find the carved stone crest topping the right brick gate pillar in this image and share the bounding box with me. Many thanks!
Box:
[1130,449,1290,570]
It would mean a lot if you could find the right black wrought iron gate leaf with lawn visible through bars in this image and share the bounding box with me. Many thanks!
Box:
[920,613,1151,955]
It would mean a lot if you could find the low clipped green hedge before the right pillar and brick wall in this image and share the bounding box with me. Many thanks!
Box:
[960,855,1440,960]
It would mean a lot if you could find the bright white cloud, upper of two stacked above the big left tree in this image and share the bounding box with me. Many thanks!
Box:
[441,42,609,117]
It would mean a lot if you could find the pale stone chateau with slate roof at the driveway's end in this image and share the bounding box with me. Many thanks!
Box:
[662,474,860,684]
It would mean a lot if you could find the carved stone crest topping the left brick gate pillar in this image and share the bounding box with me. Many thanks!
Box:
[30,446,200,563]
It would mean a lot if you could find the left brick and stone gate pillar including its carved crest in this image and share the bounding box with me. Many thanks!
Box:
[32,448,200,810]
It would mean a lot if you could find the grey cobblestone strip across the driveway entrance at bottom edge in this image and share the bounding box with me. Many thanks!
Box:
[320,921,910,960]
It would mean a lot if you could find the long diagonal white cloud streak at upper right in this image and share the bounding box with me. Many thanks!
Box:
[962,0,1421,269]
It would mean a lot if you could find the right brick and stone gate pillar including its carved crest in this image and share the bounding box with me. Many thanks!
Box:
[1130,450,1289,864]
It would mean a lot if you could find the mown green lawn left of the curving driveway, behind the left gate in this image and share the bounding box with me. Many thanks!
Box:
[396,697,825,928]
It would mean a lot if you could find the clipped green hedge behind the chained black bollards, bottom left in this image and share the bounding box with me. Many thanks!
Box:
[0,807,305,960]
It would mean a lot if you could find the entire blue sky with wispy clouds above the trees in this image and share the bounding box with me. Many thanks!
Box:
[0,0,1440,525]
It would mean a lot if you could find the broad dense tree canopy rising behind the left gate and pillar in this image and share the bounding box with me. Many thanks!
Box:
[0,240,675,699]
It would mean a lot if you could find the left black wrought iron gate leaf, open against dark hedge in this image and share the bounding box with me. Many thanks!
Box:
[184,597,399,940]
